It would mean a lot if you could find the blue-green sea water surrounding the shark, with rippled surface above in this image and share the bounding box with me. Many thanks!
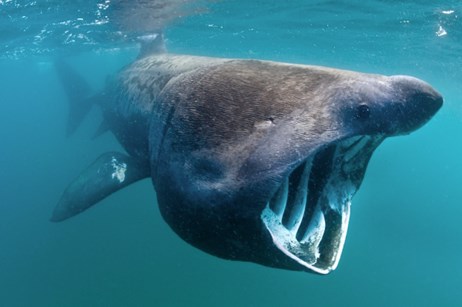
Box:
[0,0,462,306]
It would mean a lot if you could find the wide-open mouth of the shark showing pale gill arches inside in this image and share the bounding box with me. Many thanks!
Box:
[261,135,384,274]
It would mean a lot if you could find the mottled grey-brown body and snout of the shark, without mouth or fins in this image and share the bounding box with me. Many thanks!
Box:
[90,54,441,270]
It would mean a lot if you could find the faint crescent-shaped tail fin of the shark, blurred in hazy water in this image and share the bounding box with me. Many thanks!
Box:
[55,59,95,136]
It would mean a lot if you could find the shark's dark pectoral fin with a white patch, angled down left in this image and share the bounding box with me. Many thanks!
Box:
[51,152,150,222]
